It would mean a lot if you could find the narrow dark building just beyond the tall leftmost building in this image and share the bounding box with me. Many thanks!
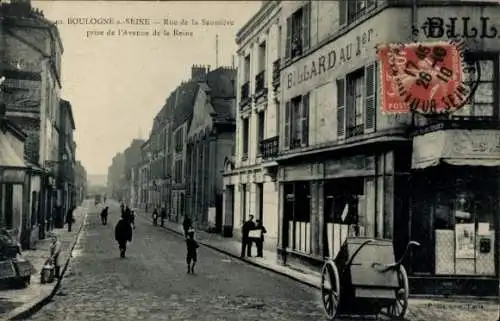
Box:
[54,99,75,228]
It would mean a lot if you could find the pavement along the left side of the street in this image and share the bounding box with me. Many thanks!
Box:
[0,207,87,320]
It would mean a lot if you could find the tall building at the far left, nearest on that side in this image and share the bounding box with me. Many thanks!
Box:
[0,0,63,239]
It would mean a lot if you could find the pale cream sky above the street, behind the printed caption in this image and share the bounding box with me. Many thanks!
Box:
[32,1,260,175]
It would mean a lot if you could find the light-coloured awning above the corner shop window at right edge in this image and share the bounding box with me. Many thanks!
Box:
[412,129,500,169]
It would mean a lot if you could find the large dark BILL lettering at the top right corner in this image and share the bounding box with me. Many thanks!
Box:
[412,17,500,39]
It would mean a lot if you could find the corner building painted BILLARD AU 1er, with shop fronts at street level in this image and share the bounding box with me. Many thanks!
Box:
[276,0,500,295]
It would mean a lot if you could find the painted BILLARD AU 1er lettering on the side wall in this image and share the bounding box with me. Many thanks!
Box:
[285,28,375,90]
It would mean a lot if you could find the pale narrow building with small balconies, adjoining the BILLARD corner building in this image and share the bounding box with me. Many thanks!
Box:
[224,1,281,249]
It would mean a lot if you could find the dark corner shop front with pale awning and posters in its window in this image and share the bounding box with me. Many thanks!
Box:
[409,129,500,296]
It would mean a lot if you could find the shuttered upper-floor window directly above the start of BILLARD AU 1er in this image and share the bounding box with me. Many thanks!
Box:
[285,2,311,58]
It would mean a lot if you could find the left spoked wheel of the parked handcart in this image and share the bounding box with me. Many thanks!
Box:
[321,261,340,320]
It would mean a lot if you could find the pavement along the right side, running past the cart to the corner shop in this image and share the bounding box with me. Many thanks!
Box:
[138,211,498,321]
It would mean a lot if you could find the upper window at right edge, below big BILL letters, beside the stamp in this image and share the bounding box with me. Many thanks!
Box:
[452,55,498,118]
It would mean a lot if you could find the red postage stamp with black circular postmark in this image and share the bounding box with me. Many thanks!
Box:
[378,42,471,114]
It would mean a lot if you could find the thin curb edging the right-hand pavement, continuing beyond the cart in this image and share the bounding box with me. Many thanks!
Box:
[140,215,498,303]
